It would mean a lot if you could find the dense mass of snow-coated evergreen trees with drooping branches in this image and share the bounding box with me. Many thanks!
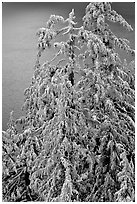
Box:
[3,2,135,202]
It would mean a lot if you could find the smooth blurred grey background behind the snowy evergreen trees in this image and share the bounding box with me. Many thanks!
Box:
[2,2,135,130]
